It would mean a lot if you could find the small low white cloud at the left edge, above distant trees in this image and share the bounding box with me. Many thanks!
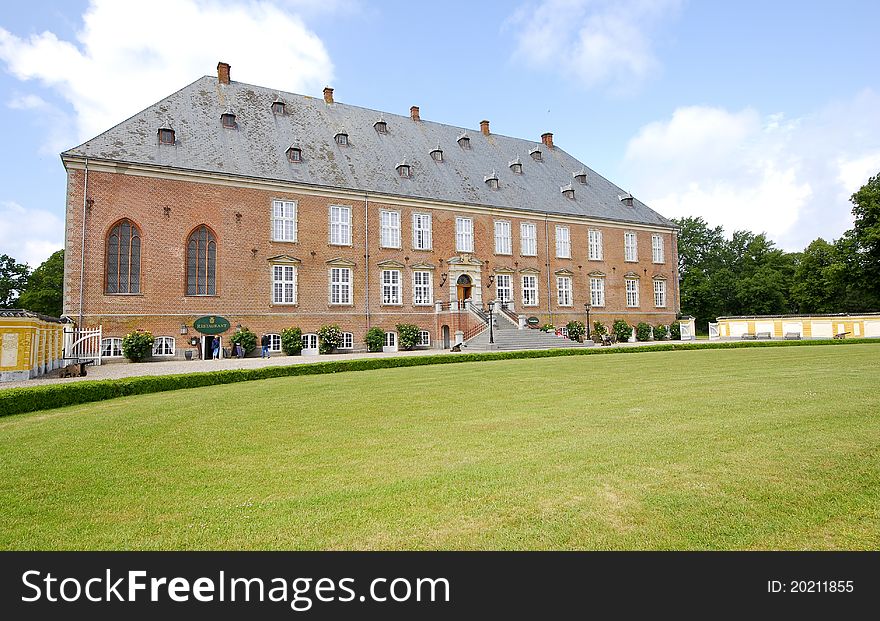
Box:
[0,201,64,268]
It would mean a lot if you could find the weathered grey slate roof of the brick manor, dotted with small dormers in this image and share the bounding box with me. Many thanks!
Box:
[62,76,674,227]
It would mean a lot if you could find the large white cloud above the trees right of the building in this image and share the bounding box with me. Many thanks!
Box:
[623,91,880,249]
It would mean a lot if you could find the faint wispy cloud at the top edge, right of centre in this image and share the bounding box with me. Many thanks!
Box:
[506,0,681,92]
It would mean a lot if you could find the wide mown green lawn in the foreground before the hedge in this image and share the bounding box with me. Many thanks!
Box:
[0,344,880,549]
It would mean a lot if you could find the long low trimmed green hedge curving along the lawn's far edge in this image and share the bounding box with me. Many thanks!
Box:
[0,339,880,416]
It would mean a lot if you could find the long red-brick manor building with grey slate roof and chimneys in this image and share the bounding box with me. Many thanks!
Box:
[62,63,679,356]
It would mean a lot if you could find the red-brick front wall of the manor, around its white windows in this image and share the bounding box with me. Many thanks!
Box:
[64,170,677,351]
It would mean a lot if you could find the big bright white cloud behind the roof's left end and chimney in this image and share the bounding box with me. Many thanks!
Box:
[0,0,333,146]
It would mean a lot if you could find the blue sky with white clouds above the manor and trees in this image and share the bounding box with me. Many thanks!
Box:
[0,0,880,266]
